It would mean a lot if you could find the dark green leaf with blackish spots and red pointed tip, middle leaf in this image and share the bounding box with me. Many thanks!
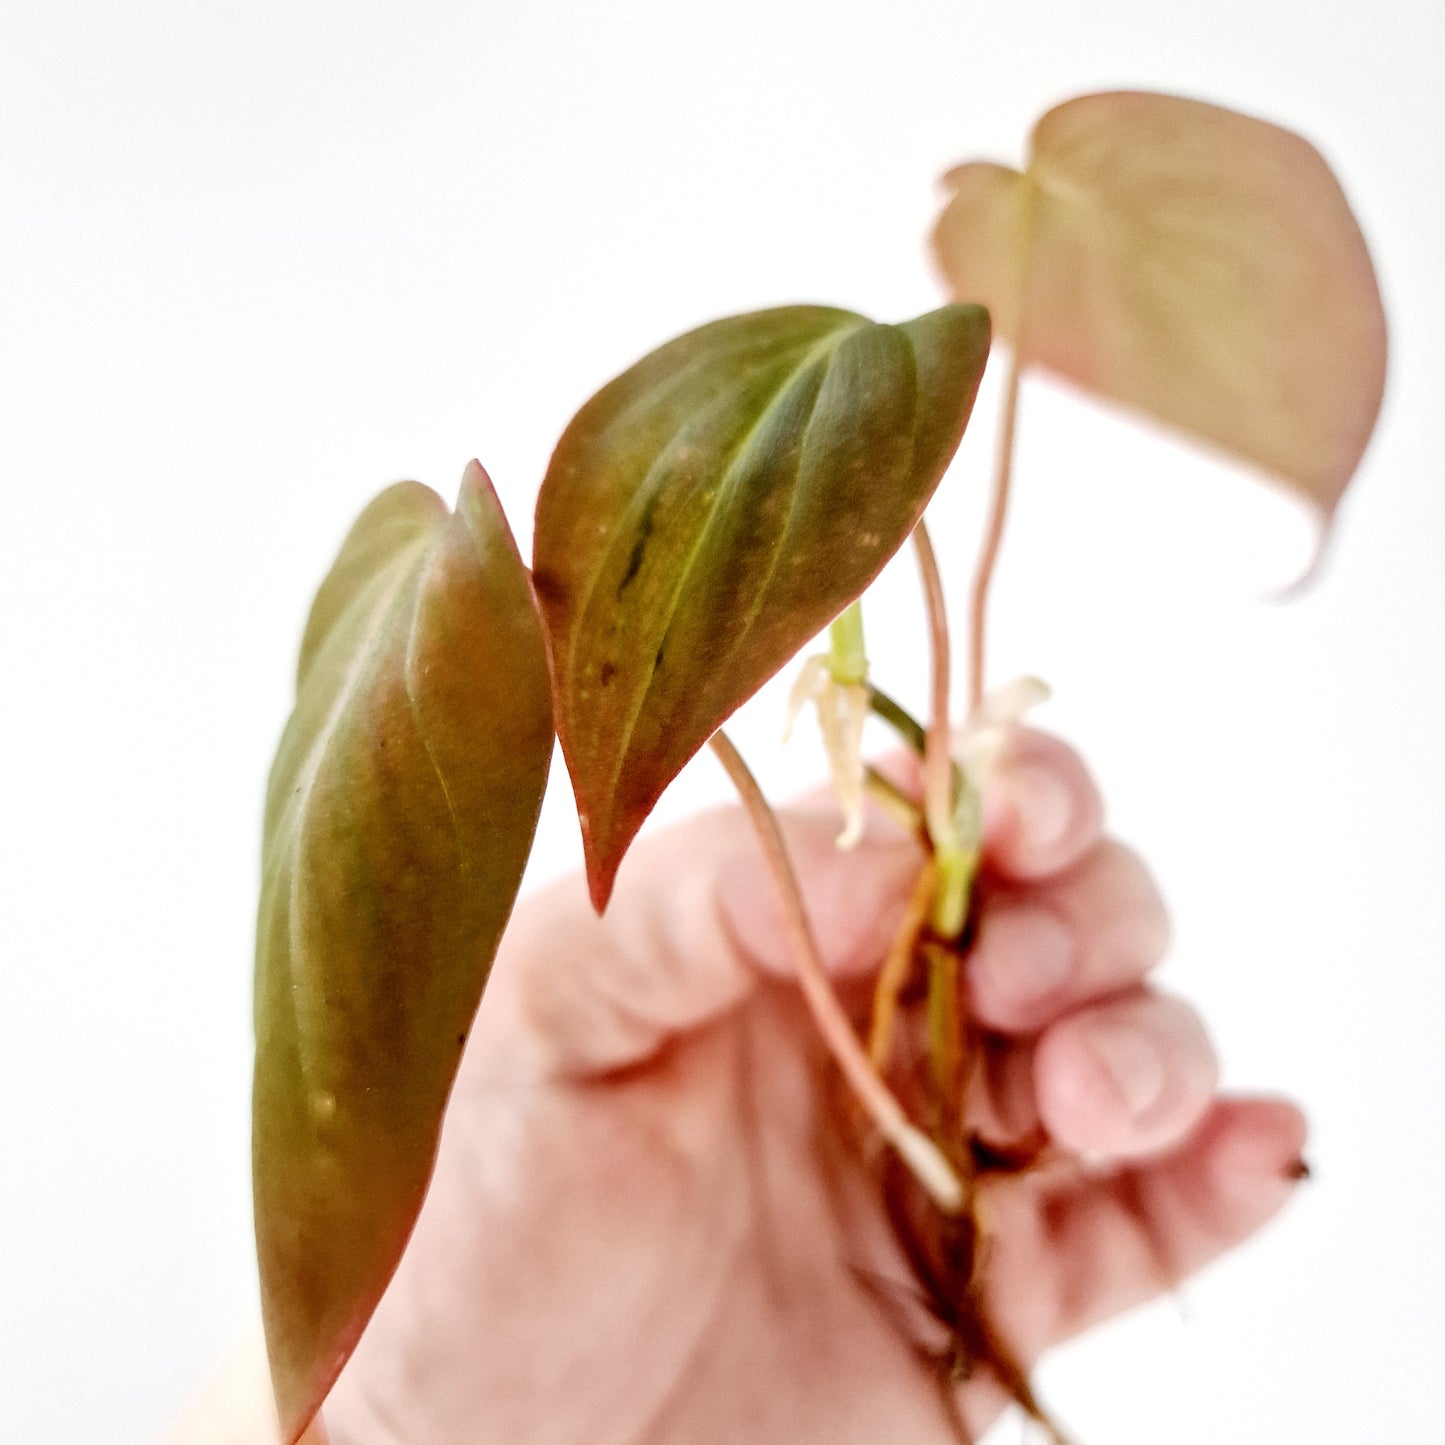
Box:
[535,306,988,909]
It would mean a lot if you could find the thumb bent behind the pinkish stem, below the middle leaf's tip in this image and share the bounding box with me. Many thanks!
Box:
[494,808,922,1074]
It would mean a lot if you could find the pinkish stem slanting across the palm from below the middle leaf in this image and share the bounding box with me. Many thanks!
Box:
[712,731,964,1214]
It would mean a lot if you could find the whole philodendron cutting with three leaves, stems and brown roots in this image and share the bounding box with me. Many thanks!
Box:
[253,94,1386,1445]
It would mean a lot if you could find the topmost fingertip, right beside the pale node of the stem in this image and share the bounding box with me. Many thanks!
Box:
[984,728,1104,881]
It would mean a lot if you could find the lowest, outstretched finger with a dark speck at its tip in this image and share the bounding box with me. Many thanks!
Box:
[994,1098,1305,1358]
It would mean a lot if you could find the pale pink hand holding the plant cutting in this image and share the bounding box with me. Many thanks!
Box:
[173,731,1303,1445]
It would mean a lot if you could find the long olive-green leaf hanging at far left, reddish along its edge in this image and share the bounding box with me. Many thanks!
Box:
[253,462,552,1442]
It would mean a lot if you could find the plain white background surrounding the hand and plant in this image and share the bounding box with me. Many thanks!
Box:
[0,0,1445,1445]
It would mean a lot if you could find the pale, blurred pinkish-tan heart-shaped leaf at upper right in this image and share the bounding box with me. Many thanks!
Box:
[933,92,1386,520]
